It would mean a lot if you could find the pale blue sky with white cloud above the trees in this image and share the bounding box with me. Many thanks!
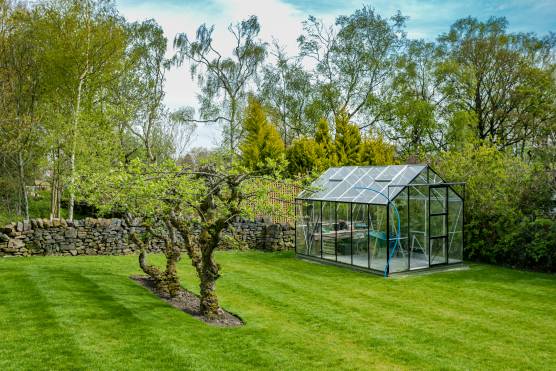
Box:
[116,0,556,148]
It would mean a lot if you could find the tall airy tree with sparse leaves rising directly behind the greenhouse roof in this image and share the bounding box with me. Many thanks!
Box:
[298,6,405,132]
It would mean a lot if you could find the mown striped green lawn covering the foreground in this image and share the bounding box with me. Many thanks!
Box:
[0,252,556,370]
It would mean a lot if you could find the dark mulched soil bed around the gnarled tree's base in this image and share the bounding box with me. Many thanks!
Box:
[130,276,244,327]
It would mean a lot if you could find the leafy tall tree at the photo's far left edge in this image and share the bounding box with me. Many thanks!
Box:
[0,2,43,220]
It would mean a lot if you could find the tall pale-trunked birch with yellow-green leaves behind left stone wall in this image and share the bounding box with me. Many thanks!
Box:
[40,0,125,219]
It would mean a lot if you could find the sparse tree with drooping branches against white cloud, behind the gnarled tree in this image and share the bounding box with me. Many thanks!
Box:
[174,16,266,156]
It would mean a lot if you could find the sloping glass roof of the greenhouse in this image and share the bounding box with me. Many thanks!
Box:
[298,165,427,205]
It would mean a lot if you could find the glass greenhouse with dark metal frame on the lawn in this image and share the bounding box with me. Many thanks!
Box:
[295,165,465,276]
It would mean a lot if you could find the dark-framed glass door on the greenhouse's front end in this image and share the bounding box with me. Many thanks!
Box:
[427,184,448,266]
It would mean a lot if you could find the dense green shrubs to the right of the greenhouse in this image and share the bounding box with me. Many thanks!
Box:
[435,144,556,272]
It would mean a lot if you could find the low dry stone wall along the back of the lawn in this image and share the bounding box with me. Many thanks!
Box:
[0,218,295,256]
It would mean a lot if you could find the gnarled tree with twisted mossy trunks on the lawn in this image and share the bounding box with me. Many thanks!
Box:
[80,160,286,319]
